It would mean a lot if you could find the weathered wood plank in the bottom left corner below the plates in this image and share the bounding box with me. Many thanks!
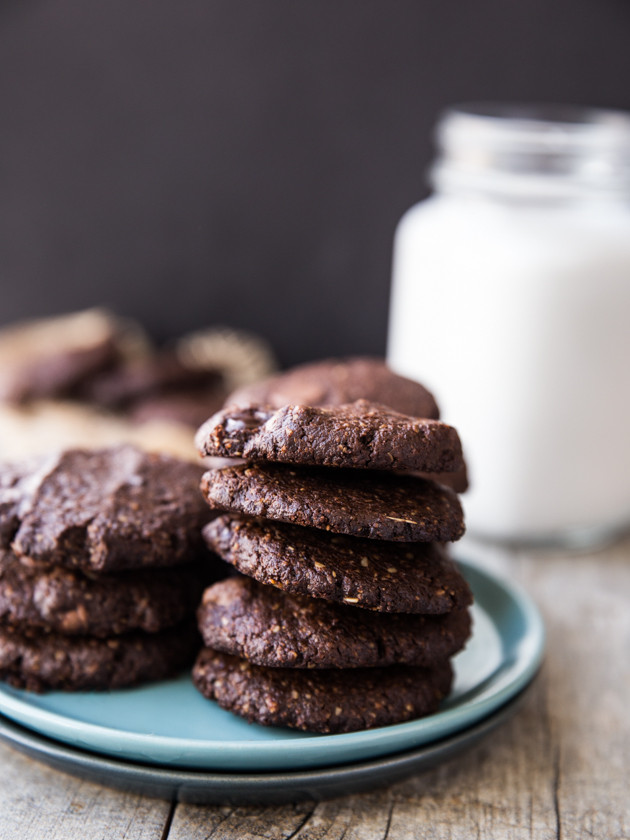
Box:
[0,744,170,840]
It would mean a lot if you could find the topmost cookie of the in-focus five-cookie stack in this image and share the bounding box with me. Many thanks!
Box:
[195,400,464,472]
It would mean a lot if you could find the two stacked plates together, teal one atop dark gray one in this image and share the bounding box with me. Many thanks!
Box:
[0,558,544,803]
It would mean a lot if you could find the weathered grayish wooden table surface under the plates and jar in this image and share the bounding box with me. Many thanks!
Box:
[0,540,630,840]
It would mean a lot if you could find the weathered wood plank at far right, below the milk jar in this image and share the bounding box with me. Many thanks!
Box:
[517,541,630,840]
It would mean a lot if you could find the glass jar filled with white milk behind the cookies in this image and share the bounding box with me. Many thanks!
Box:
[388,106,630,544]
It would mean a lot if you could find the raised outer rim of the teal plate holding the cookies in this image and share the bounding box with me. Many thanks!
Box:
[0,557,545,770]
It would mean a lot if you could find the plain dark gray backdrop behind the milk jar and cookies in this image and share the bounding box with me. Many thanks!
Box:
[0,0,630,364]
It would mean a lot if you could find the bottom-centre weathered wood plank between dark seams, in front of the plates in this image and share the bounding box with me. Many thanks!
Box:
[169,674,557,840]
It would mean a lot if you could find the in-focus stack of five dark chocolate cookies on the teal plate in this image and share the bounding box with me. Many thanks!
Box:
[193,370,471,732]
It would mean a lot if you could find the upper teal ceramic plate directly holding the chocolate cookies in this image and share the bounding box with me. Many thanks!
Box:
[0,560,544,772]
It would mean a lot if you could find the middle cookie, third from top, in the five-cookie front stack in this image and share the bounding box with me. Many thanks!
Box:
[204,516,472,615]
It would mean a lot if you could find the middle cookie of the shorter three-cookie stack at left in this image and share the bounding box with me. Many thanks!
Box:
[0,551,211,637]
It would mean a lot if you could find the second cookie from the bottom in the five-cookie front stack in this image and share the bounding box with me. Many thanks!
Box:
[197,577,470,668]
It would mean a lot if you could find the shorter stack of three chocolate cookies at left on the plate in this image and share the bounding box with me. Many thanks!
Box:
[0,446,212,691]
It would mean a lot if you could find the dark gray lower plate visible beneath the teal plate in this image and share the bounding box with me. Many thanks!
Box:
[0,683,531,805]
